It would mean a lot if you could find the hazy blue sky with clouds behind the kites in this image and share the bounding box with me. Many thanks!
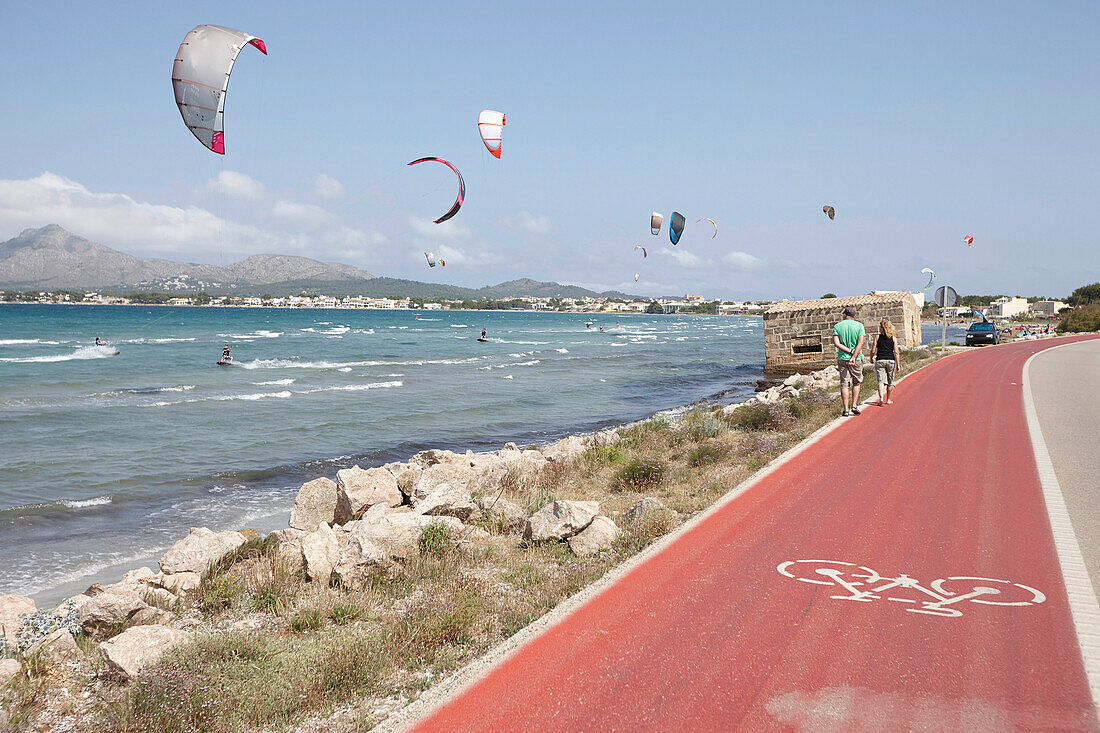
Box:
[0,0,1100,299]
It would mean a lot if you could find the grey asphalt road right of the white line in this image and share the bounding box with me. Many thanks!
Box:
[1031,340,1100,595]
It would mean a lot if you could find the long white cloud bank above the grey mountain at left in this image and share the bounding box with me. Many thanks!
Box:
[0,172,386,259]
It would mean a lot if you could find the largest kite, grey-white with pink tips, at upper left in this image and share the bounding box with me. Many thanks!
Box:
[172,25,267,155]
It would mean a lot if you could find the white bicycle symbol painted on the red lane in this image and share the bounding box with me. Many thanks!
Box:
[776,560,1046,616]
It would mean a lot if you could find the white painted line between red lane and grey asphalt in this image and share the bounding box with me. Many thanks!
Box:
[1023,341,1100,705]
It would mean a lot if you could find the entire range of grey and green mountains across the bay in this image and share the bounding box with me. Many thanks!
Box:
[0,225,635,299]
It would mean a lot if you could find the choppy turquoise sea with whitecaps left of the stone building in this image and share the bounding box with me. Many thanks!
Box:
[0,305,763,593]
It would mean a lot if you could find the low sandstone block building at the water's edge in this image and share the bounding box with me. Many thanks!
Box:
[763,291,921,374]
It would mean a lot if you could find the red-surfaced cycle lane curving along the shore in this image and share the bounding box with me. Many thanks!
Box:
[416,339,1100,731]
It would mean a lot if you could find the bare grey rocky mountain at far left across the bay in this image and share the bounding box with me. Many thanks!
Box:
[0,225,374,291]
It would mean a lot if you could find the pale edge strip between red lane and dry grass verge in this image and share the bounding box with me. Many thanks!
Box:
[385,351,974,733]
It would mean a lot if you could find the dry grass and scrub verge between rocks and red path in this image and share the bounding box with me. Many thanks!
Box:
[2,349,936,733]
